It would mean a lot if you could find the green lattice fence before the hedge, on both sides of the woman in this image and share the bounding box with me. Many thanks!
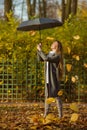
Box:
[0,59,87,102]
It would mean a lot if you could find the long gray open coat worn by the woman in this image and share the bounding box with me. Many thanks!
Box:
[37,51,60,97]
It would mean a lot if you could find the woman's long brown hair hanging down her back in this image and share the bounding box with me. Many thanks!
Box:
[56,41,63,80]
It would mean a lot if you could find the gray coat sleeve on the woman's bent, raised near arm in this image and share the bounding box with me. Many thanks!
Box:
[38,51,60,63]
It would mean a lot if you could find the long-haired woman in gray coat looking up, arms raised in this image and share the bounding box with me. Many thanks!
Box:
[37,41,63,118]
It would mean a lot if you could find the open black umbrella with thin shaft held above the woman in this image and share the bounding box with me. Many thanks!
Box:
[17,18,62,40]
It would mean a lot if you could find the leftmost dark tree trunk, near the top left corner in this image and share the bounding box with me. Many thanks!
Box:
[4,0,12,21]
